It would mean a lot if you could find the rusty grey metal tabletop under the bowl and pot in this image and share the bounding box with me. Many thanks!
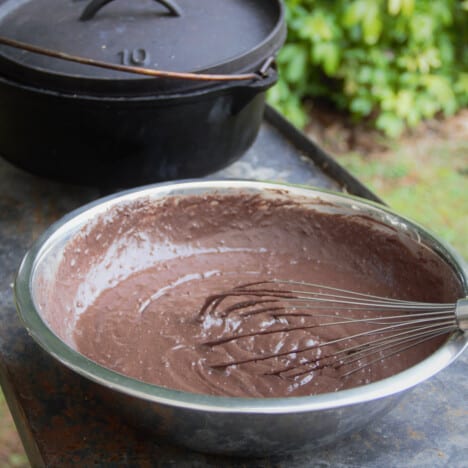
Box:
[0,113,468,468]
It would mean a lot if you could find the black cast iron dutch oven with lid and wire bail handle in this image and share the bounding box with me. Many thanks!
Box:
[0,0,286,187]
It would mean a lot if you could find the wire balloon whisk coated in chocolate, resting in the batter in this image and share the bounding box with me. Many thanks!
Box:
[200,280,468,378]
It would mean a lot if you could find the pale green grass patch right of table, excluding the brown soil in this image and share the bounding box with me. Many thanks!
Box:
[339,126,468,260]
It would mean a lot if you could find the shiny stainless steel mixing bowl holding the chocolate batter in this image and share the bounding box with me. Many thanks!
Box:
[15,181,468,456]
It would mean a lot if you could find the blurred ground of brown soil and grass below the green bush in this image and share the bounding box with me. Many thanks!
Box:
[306,102,468,260]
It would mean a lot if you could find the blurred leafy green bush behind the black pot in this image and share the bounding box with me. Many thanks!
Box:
[268,0,468,137]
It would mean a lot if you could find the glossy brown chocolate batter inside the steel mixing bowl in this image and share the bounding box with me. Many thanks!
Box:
[36,193,461,397]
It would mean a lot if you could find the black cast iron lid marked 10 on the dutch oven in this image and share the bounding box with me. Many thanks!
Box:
[0,0,286,95]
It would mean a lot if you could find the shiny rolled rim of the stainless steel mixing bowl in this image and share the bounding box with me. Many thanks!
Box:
[14,179,468,414]
